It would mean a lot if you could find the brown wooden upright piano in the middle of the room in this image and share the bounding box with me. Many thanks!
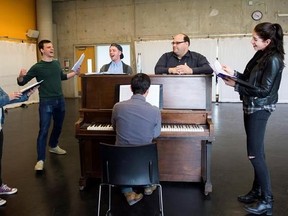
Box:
[75,74,214,195]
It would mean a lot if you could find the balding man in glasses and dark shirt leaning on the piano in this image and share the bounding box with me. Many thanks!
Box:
[154,33,213,75]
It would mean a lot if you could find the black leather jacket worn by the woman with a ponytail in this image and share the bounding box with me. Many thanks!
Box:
[236,51,284,107]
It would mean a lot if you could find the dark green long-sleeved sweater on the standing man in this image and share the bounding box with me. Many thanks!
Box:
[18,60,67,99]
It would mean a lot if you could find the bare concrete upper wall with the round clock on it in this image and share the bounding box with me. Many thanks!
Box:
[53,0,288,95]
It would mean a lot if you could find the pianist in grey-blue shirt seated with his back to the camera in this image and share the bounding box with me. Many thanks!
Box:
[111,73,161,205]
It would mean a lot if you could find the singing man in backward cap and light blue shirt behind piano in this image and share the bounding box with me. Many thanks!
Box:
[100,43,133,74]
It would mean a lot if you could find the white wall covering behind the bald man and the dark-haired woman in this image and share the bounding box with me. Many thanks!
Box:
[135,36,288,103]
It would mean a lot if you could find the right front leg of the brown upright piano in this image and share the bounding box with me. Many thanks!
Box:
[202,140,212,196]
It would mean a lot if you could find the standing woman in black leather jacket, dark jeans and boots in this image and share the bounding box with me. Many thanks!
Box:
[223,22,285,215]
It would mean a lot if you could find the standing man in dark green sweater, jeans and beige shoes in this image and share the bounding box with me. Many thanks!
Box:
[17,40,79,171]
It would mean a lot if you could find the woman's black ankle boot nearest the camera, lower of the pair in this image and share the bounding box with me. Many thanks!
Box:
[244,196,273,215]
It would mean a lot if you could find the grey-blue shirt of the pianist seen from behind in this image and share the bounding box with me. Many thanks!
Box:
[111,95,161,145]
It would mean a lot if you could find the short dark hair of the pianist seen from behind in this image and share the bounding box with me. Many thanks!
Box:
[131,73,151,95]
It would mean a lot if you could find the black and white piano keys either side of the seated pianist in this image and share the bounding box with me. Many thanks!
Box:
[87,124,204,132]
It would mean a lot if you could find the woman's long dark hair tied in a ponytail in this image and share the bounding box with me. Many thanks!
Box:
[254,22,285,60]
